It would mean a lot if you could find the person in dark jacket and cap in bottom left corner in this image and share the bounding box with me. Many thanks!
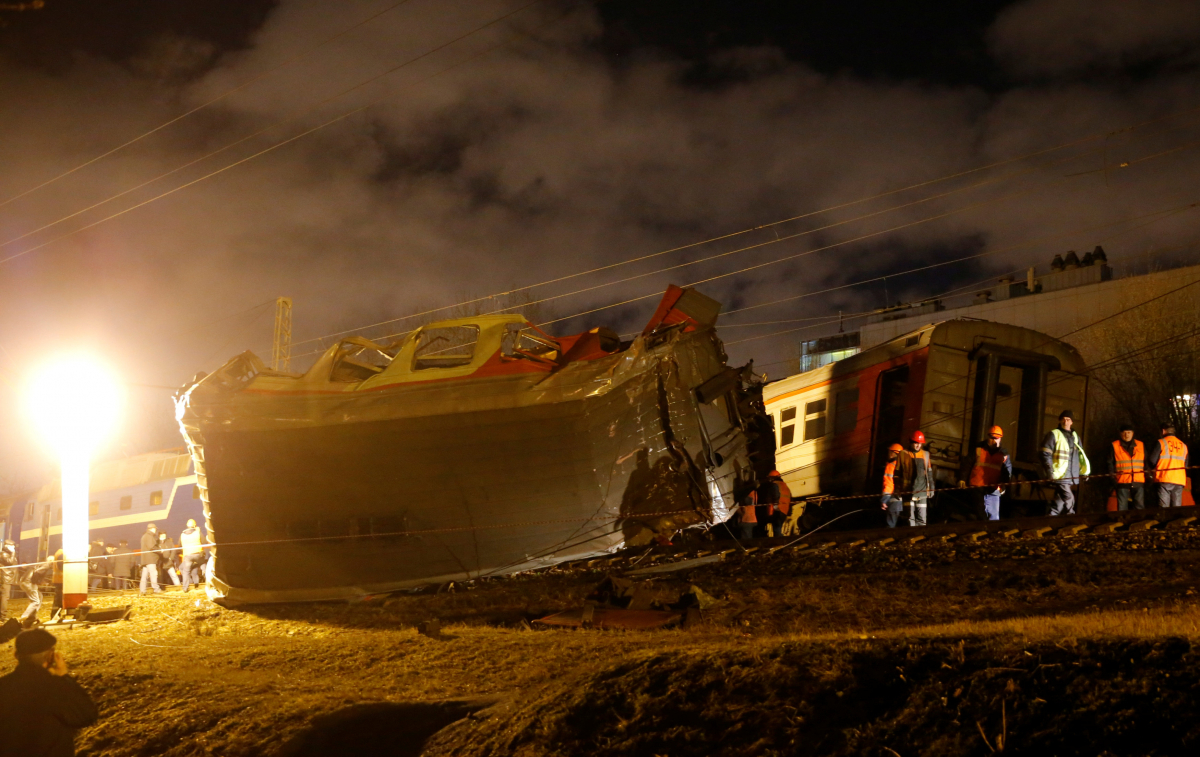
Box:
[0,629,97,757]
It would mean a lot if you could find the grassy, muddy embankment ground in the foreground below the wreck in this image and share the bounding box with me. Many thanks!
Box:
[0,529,1200,757]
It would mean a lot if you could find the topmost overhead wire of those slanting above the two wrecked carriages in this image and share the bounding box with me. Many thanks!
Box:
[285,106,1200,344]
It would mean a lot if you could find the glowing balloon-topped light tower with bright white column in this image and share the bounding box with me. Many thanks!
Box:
[25,355,121,609]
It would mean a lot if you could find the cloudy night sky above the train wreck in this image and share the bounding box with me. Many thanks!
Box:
[0,0,1200,488]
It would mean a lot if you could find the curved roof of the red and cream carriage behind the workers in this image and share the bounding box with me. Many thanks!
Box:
[762,318,1085,402]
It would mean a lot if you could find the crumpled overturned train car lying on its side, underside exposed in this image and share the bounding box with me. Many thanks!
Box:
[176,287,769,603]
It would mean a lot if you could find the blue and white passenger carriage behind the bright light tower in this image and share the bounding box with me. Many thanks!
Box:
[8,450,204,560]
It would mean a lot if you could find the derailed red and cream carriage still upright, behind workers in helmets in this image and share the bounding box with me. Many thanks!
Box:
[763,319,1087,528]
